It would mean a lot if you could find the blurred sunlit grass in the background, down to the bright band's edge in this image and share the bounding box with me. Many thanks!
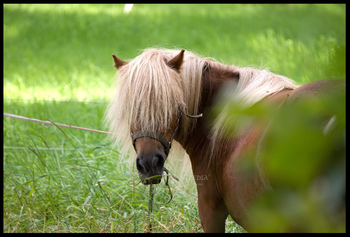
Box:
[3,4,345,100]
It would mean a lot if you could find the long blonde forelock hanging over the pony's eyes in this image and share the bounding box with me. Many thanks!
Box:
[109,51,184,136]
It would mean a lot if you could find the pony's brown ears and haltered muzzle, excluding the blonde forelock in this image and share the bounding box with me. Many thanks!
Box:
[112,50,185,185]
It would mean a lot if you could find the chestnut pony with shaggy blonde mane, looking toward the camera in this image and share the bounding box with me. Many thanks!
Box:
[106,48,345,232]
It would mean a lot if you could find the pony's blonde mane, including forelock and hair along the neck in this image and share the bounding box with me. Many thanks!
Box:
[105,48,298,176]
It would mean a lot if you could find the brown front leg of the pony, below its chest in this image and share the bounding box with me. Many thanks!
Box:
[198,189,228,233]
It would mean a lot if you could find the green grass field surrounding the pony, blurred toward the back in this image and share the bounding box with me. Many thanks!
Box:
[3,4,345,232]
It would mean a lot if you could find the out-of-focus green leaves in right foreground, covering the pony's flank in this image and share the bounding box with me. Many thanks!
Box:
[216,80,346,232]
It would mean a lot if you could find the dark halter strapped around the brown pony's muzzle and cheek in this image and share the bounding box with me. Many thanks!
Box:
[130,109,203,156]
